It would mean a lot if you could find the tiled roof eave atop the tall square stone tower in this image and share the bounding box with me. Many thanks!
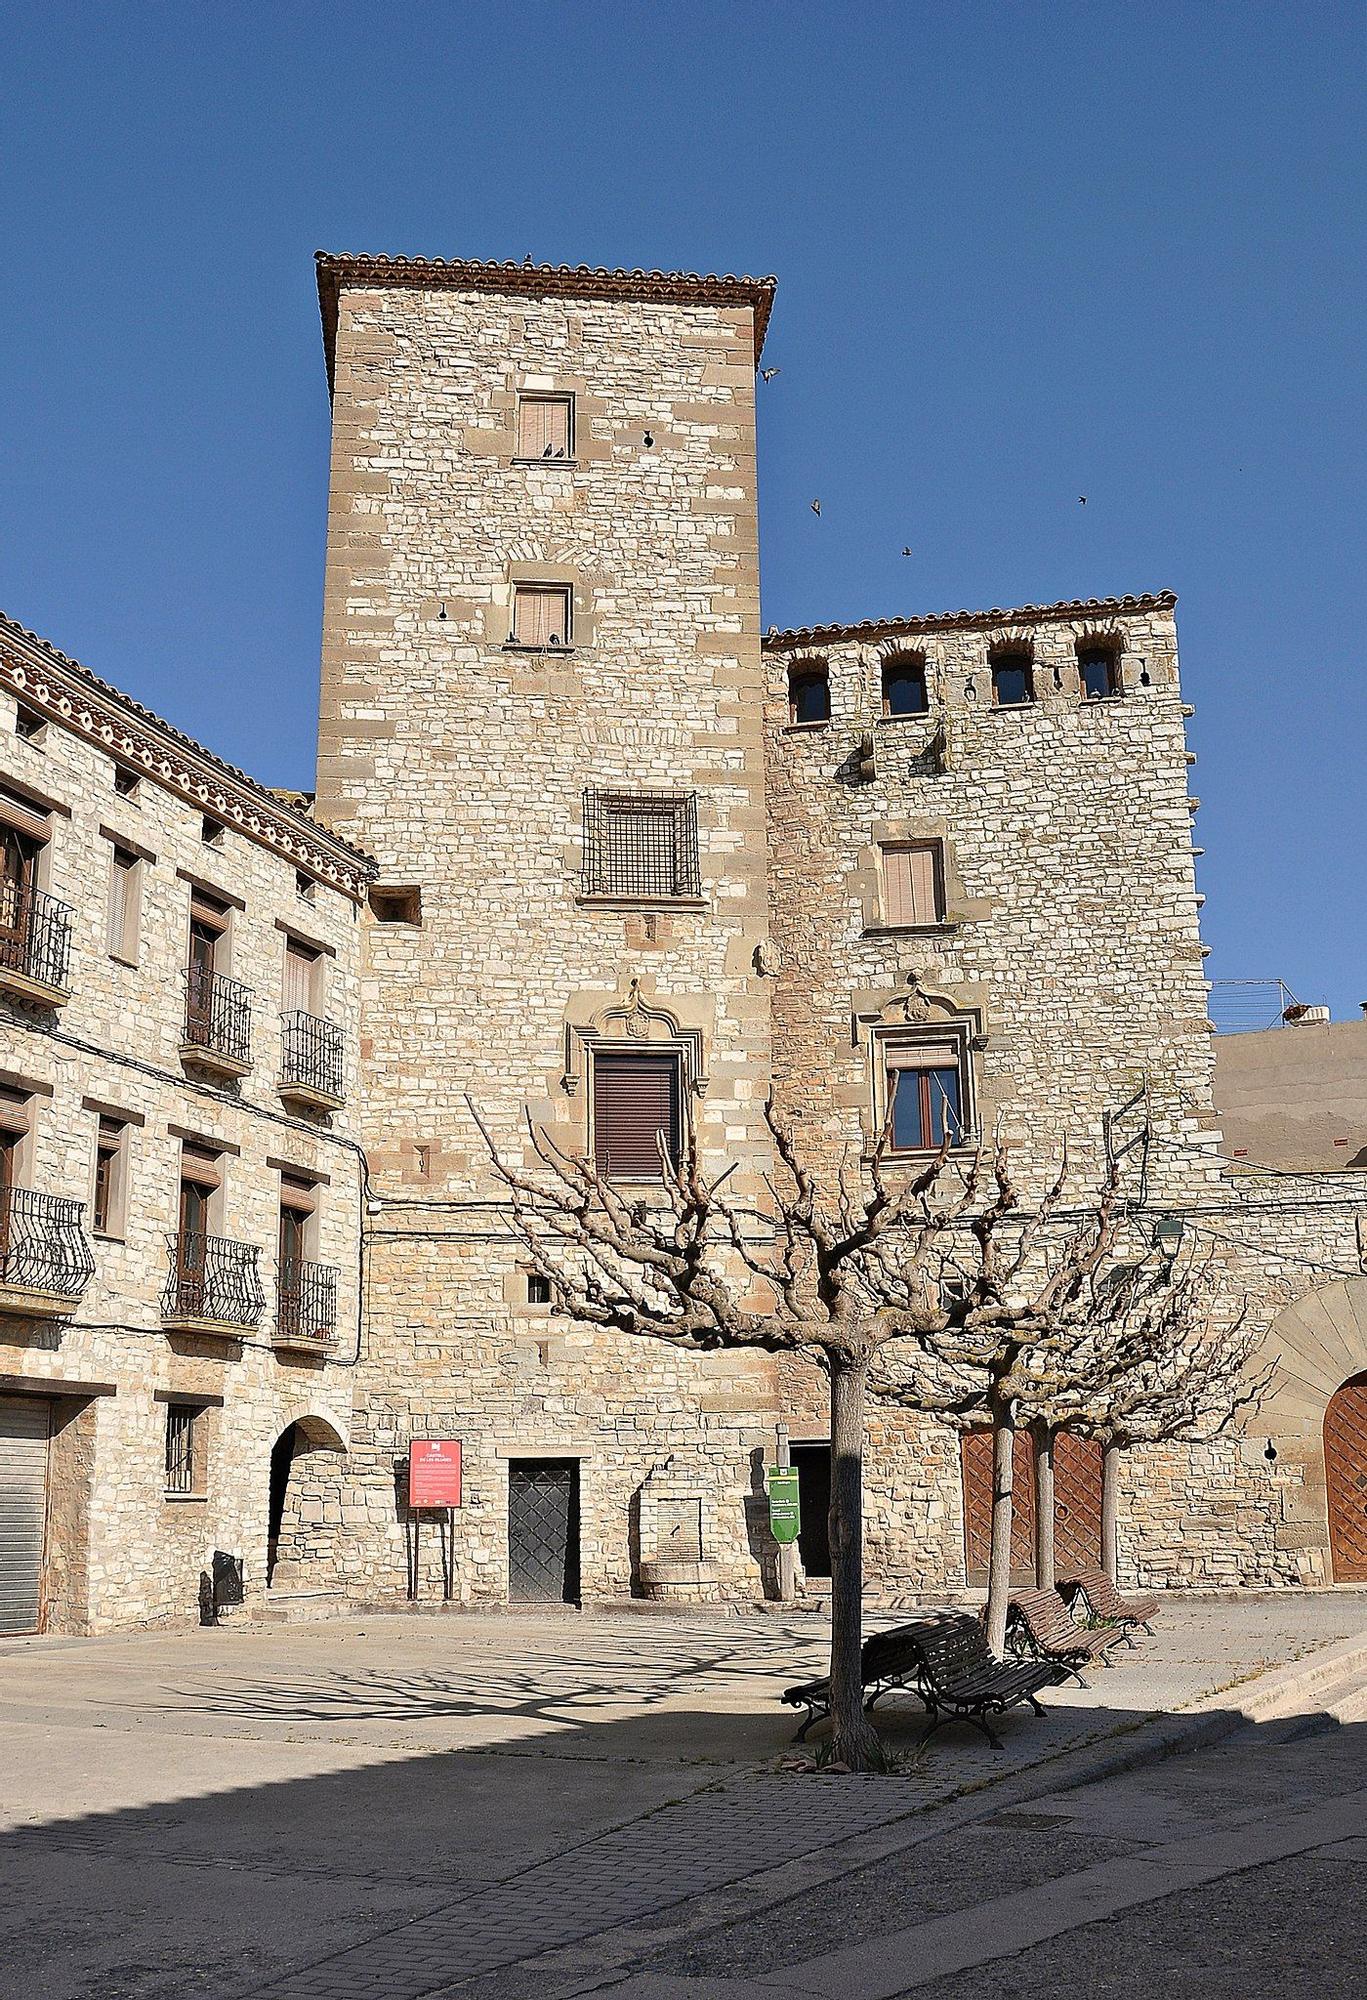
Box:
[314,250,777,388]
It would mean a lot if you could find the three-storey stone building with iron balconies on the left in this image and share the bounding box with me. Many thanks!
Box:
[0,620,372,1632]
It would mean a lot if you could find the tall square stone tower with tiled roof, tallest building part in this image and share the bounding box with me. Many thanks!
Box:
[309,256,773,1598]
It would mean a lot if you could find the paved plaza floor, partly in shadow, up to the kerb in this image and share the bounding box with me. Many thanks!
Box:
[0,1594,1367,2000]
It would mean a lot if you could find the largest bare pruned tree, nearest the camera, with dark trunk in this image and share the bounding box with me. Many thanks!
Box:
[470,1104,991,1770]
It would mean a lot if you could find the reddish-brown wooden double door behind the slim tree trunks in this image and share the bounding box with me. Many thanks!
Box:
[961,1430,1101,1586]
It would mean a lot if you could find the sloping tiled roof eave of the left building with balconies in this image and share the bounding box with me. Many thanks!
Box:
[0,612,378,902]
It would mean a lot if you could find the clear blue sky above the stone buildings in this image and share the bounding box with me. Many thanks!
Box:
[0,0,1367,1014]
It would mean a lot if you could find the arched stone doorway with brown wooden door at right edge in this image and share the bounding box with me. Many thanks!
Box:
[1249,1276,1367,1584]
